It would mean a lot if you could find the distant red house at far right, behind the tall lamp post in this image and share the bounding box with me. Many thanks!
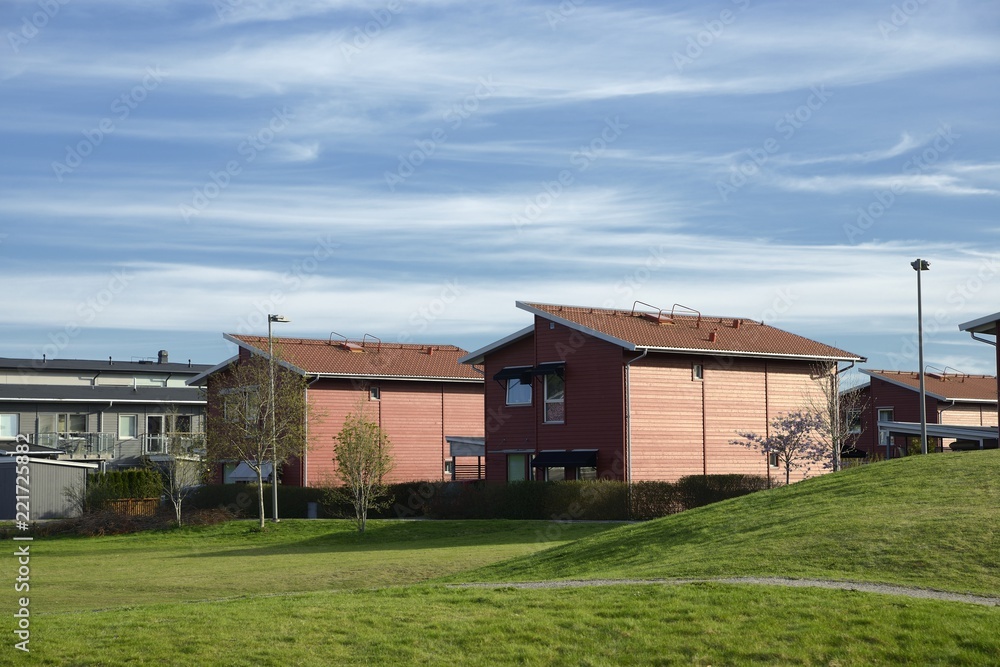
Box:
[848,370,997,458]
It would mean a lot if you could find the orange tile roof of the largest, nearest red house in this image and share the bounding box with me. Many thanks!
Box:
[517,302,865,361]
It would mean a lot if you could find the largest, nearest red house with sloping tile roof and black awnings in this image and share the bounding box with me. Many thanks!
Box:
[462,302,864,481]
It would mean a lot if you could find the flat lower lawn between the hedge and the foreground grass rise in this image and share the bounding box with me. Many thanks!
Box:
[13,520,614,612]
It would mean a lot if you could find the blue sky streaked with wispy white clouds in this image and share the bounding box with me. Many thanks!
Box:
[0,0,1000,372]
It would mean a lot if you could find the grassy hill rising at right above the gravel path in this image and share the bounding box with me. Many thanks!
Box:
[461,451,1000,595]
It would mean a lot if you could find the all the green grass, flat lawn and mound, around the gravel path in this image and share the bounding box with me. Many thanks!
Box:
[0,452,1000,667]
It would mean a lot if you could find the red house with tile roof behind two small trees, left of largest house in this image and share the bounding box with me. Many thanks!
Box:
[191,334,483,486]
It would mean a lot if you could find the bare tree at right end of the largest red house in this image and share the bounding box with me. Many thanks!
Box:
[809,362,868,472]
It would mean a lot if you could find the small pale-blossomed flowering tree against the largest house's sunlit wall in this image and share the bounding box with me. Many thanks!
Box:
[730,411,832,484]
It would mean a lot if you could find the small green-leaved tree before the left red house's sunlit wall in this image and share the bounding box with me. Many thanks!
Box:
[333,406,393,533]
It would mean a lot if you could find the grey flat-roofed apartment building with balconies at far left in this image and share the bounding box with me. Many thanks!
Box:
[0,350,209,467]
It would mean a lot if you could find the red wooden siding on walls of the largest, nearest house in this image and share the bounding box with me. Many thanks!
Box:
[485,317,822,481]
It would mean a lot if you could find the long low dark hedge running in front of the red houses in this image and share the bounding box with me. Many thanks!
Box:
[185,475,767,521]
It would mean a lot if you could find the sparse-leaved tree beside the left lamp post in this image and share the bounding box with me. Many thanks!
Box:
[207,350,306,528]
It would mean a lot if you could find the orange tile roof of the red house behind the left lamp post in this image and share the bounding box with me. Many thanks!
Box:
[231,334,483,382]
